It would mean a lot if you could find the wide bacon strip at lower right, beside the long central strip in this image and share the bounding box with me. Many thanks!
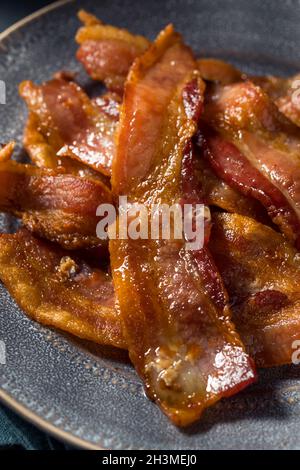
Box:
[209,214,300,366]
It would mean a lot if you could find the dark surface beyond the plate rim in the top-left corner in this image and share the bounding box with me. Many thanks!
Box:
[0,0,53,32]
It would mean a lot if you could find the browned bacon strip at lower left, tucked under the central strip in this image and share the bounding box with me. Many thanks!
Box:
[0,229,125,348]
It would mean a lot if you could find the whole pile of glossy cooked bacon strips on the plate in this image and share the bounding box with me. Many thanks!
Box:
[0,11,300,426]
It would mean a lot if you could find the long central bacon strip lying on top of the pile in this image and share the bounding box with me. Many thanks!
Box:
[110,26,255,425]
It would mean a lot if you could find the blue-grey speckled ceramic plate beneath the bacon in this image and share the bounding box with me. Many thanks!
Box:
[0,0,300,450]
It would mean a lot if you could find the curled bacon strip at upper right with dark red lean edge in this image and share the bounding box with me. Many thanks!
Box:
[200,82,300,247]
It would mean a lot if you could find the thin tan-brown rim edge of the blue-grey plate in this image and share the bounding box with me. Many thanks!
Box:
[0,0,102,450]
